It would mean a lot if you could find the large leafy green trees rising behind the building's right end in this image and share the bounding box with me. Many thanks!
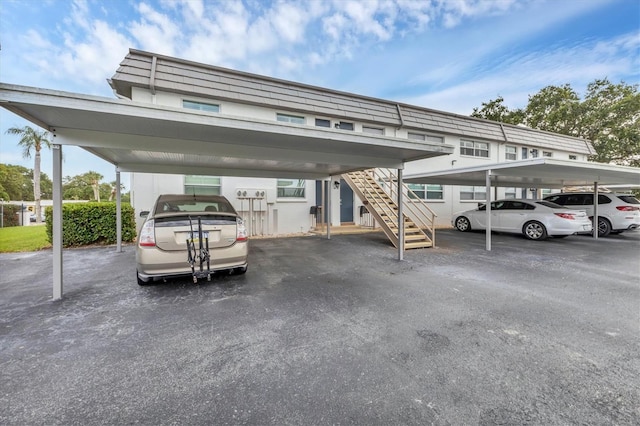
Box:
[471,79,640,167]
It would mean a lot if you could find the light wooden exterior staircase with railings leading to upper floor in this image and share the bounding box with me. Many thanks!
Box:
[342,169,436,250]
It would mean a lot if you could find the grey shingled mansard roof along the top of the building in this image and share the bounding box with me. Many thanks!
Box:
[110,49,595,154]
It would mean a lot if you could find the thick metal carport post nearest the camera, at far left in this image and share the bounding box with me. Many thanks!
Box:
[51,144,62,300]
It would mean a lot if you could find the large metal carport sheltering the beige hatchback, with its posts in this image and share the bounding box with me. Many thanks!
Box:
[0,83,453,300]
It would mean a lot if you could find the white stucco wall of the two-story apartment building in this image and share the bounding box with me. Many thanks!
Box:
[126,87,587,235]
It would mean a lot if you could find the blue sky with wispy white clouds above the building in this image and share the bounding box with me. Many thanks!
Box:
[0,0,640,190]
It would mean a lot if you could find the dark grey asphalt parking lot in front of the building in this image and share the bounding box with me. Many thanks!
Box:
[0,230,640,425]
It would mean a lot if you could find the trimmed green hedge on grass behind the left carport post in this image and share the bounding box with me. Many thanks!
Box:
[45,202,136,247]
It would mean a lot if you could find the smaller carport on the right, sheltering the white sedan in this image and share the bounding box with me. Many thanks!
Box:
[404,158,640,251]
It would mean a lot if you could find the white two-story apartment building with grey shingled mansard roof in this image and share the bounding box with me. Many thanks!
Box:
[110,50,593,235]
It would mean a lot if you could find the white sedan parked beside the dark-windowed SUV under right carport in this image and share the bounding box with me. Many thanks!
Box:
[452,199,592,240]
